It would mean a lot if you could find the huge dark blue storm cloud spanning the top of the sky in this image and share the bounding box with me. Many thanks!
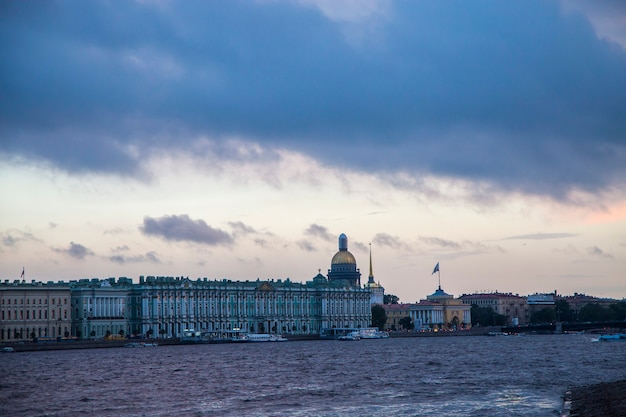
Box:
[0,0,626,198]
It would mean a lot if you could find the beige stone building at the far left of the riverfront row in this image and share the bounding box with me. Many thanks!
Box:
[0,280,72,342]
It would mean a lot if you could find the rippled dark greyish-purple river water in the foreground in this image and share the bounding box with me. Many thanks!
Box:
[0,335,626,417]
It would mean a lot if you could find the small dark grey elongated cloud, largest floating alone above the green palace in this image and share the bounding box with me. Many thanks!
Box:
[139,214,234,246]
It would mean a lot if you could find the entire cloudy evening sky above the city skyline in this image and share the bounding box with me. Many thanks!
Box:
[0,0,626,302]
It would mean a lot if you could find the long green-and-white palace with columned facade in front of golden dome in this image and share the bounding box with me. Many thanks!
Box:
[128,274,371,337]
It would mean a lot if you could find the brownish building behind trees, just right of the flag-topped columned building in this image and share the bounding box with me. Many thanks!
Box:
[459,291,530,326]
